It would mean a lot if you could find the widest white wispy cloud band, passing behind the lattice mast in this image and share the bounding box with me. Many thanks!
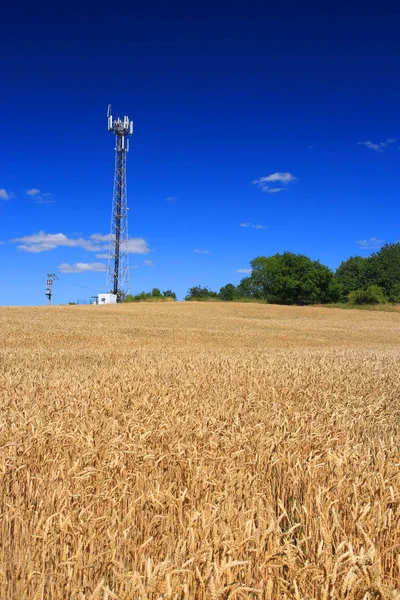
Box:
[11,231,150,254]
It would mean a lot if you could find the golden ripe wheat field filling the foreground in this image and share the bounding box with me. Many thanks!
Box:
[0,303,400,600]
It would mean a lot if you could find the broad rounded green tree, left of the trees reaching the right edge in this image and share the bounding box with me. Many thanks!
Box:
[250,252,333,305]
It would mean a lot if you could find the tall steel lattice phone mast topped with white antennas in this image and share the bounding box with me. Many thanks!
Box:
[107,104,133,301]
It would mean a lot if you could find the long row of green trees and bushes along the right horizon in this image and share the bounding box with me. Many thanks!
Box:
[185,242,400,305]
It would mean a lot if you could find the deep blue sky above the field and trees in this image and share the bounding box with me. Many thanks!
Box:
[0,1,400,304]
